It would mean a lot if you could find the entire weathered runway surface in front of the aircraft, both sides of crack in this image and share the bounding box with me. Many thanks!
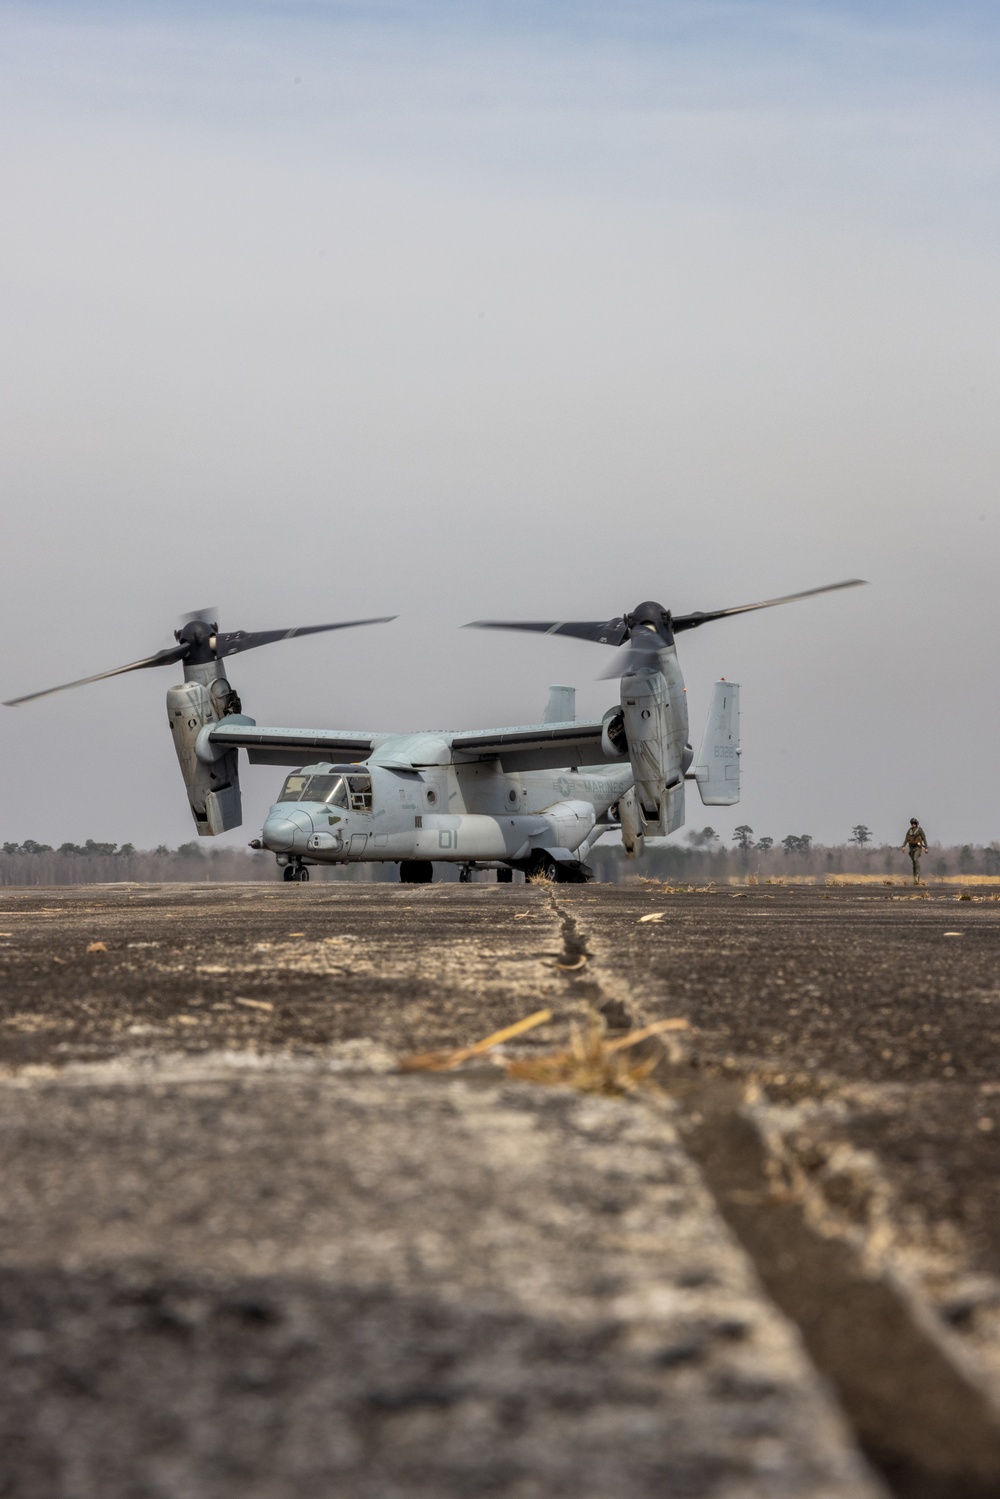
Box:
[0,881,1000,1499]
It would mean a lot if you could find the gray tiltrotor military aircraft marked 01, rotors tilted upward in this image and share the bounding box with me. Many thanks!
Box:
[6,579,864,884]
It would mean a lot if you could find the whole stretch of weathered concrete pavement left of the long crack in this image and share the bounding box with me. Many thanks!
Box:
[0,886,882,1499]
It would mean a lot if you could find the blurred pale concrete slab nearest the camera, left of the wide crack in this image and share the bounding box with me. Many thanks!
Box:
[0,1061,880,1499]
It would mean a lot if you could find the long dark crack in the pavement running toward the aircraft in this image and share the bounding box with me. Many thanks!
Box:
[553,898,1000,1499]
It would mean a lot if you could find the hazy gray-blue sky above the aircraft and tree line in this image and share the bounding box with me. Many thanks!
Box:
[0,0,1000,845]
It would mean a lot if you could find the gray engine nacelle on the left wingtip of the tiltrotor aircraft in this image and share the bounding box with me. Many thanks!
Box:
[166,674,253,838]
